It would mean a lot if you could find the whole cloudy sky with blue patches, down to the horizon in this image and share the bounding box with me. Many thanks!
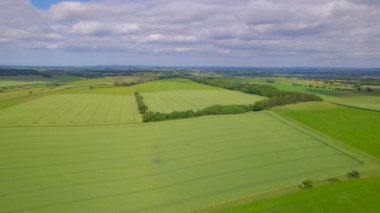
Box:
[0,0,380,67]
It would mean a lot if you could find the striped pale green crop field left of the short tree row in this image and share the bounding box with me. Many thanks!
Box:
[0,94,140,126]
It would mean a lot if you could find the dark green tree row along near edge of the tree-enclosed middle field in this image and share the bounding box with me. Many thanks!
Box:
[143,105,252,122]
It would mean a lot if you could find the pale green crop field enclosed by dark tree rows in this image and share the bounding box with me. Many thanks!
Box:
[142,90,263,113]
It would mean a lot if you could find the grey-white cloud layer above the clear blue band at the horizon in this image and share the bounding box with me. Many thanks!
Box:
[0,0,380,65]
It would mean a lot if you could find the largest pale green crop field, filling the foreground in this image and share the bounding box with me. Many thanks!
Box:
[0,112,377,212]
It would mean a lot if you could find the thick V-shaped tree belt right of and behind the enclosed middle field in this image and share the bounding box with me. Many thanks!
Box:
[191,78,322,111]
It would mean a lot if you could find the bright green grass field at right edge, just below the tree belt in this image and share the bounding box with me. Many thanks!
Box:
[274,102,380,158]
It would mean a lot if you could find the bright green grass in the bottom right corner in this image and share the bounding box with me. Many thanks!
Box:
[223,178,380,213]
